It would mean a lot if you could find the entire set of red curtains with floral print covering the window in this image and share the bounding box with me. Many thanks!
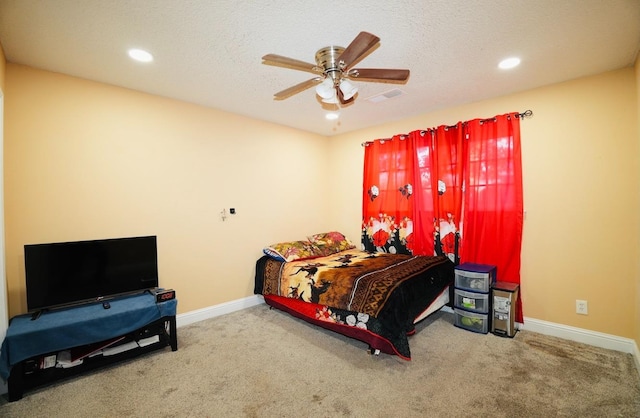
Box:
[362,113,523,322]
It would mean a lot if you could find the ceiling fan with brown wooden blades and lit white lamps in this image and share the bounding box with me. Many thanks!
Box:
[262,32,409,105]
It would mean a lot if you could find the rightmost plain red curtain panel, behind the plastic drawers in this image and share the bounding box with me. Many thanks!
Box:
[460,113,524,322]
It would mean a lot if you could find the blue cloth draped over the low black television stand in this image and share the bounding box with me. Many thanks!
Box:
[0,292,178,381]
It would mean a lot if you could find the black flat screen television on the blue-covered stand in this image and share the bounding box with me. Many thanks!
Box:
[24,236,158,312]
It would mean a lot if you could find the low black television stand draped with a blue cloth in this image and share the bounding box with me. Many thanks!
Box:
[0,293,178,402]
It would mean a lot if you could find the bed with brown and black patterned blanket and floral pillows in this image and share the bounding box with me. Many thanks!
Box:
[254,232,454,360]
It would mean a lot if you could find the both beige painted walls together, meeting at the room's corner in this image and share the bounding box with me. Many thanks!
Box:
[5,64,640,341]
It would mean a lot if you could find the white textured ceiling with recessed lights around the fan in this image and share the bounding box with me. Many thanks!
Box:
[0,0,640,136]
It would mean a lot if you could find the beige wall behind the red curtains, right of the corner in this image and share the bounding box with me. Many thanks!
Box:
[330,68,640,338]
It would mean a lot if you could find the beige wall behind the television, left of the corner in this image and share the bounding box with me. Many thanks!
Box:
[4,63,331,315]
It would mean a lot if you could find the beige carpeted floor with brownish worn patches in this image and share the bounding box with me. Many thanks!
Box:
[0,305,640,418]
